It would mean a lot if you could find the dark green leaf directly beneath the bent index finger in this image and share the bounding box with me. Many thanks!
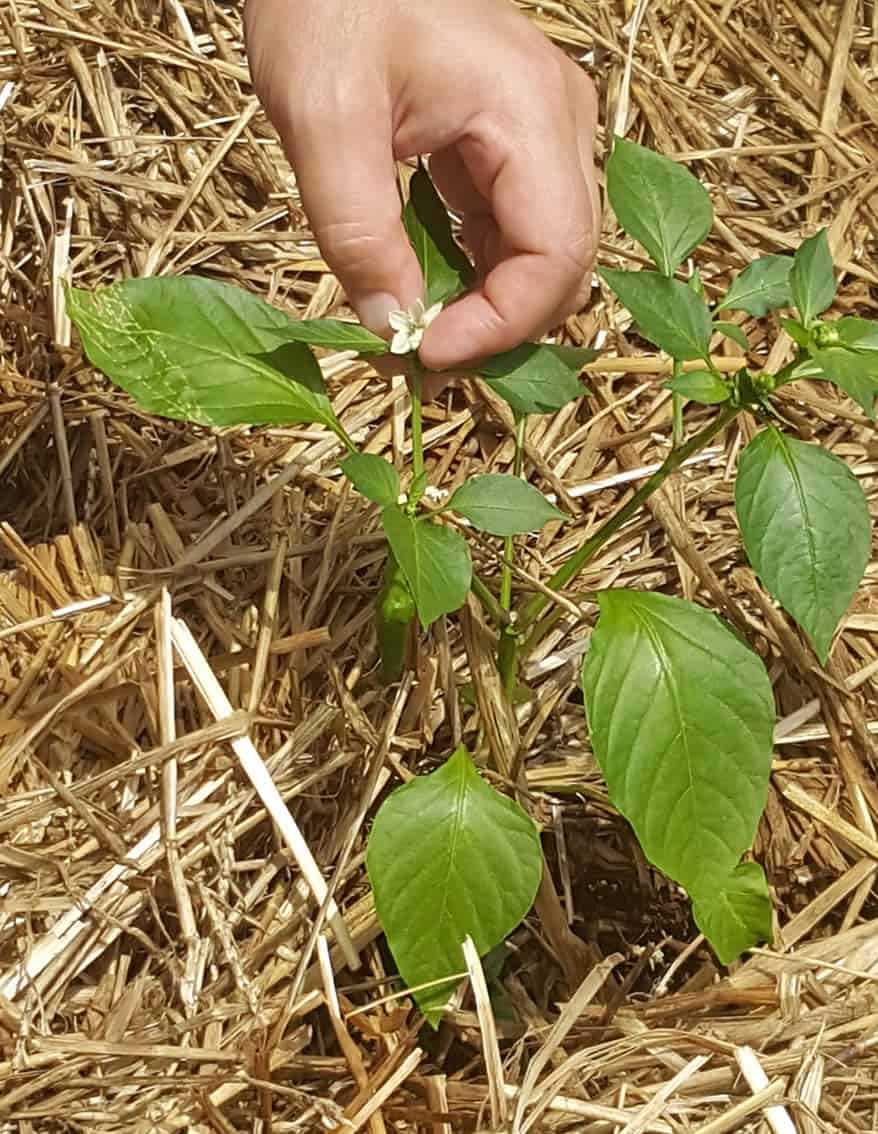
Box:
[475,342,597,416]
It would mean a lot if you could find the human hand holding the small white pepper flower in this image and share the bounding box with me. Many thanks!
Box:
[245,0,599,370]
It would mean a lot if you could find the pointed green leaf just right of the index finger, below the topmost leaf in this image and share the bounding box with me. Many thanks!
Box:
[599,268,712,359]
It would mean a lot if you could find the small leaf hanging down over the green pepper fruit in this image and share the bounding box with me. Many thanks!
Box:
[381,505,473,629]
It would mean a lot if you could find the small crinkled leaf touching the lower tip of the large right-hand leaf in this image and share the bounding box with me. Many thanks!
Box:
[692,862,773,965]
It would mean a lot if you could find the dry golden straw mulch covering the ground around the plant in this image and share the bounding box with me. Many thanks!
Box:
[0,0,878,1134]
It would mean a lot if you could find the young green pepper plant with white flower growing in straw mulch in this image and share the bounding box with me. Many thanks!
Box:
[67,138,878,1023]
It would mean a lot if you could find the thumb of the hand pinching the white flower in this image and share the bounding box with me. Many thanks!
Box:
[287,97,423,335]
